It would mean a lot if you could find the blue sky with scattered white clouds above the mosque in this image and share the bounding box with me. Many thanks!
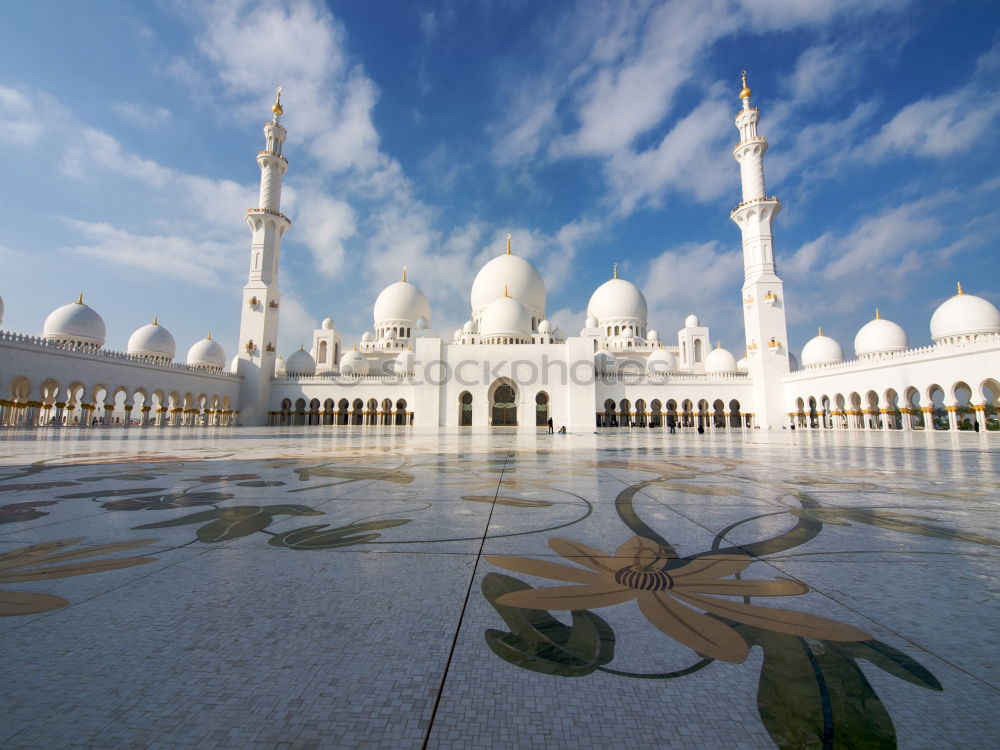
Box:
[0,0,1000,364]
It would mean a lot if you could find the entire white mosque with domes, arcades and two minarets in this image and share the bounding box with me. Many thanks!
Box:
[0,74,1000,432]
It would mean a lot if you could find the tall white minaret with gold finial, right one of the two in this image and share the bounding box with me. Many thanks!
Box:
[729,76,788,427]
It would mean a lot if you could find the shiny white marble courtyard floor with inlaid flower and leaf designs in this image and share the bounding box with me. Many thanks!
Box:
[0,427,1000,750]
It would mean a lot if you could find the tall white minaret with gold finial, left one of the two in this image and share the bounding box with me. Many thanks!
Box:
[237,87,292,425]
